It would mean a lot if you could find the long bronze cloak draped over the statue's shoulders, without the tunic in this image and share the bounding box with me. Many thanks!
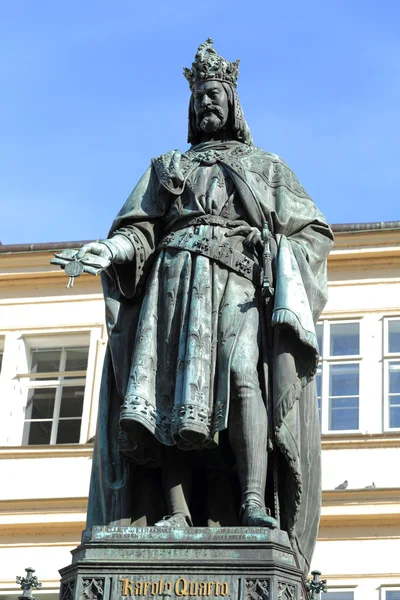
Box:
[87,142,333,572]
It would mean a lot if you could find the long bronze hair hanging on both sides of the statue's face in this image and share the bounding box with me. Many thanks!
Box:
[188,81,254,146]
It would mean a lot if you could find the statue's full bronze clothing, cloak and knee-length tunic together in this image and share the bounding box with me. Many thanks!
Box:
[88,142,333,569]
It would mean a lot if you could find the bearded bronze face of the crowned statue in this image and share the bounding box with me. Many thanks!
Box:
[193,81,229,134]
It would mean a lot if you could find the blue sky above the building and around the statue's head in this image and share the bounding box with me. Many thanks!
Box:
[0,0,400,244]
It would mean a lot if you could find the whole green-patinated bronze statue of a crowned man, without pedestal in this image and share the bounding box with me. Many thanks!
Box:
[56,39,333,570]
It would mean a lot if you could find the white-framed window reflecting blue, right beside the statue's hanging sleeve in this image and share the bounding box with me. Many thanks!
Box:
[316,321,361,433]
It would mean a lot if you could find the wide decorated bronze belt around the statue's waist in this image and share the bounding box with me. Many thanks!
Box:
[158,231,263,287]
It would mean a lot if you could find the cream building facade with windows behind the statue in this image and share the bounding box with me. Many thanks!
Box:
[0,222,400,600]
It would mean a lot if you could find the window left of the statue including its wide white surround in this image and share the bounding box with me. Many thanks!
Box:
[0,325,106,452]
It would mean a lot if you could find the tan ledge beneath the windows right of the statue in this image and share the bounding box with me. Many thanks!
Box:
[321,431,400,450]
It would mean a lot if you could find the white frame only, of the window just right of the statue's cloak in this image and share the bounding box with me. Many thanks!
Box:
[318,316,364,435]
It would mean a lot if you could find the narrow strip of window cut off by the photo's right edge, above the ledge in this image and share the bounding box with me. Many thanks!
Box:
[383,318,400,429]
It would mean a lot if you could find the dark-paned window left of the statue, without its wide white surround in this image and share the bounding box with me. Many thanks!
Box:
[19,339,89,446]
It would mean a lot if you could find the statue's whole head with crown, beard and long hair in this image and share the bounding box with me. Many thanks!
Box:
[184,38,253,146]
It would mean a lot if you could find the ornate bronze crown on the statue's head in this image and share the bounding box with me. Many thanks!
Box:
[183,38,240,90]
